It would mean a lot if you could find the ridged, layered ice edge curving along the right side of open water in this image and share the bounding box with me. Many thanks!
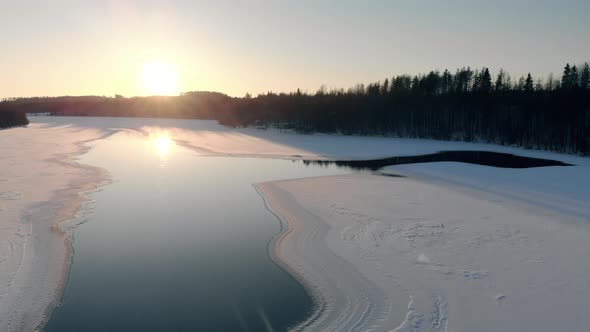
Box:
[253,176,408,331]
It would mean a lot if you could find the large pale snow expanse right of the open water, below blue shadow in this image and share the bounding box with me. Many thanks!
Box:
[256,166,590,331]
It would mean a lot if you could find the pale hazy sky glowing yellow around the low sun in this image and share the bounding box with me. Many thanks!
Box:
[0,0,590,98]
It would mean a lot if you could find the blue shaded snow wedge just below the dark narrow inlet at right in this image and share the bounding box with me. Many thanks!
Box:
[383,160,590,222]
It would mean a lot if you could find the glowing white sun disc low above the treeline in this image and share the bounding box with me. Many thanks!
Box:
[141,60,180,96]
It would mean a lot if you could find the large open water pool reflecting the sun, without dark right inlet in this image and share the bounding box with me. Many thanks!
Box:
[45,132,347,332]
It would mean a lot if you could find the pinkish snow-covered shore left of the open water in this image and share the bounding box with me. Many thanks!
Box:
[0,124,109,331]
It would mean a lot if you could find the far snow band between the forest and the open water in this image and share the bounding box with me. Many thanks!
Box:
[30,117,590,165]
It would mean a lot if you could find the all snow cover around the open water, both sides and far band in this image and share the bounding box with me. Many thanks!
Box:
[0,117,590,331]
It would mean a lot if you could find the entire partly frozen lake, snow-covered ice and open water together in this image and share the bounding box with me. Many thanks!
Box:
[6,117,590,331]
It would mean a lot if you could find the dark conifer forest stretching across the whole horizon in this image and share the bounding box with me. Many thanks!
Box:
[0,63,590,155]
